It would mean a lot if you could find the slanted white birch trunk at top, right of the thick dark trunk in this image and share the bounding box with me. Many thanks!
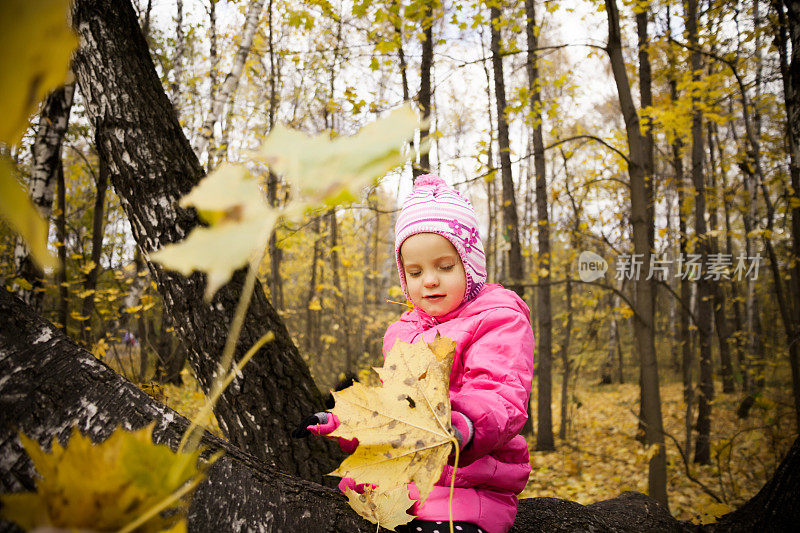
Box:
[194,0,264,161]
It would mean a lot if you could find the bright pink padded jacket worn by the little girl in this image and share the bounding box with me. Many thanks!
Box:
[383,284,534,533]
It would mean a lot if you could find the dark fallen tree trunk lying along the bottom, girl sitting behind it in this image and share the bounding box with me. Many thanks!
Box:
[0,289,800,533]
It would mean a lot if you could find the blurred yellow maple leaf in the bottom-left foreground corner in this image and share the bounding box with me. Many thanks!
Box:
[0,424,212,532]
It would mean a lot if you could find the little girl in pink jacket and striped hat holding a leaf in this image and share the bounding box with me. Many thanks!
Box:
[296,174,534,533]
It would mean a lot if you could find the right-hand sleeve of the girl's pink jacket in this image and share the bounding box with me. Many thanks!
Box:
[450,308,534,465]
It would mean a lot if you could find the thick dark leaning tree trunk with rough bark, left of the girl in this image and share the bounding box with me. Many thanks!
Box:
[72,0,339,480]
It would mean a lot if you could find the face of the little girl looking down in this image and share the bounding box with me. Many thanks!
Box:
[400,233,467,316]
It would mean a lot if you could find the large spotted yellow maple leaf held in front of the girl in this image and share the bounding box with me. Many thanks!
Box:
[331,339,454,501]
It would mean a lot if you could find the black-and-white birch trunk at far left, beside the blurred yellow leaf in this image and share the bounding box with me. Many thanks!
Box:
[14,83,75,309]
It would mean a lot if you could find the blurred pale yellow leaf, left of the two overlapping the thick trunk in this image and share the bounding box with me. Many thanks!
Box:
[150,164,278,300]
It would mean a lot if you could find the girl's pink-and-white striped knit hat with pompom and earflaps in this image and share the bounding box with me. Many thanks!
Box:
[394,174,486,301]
